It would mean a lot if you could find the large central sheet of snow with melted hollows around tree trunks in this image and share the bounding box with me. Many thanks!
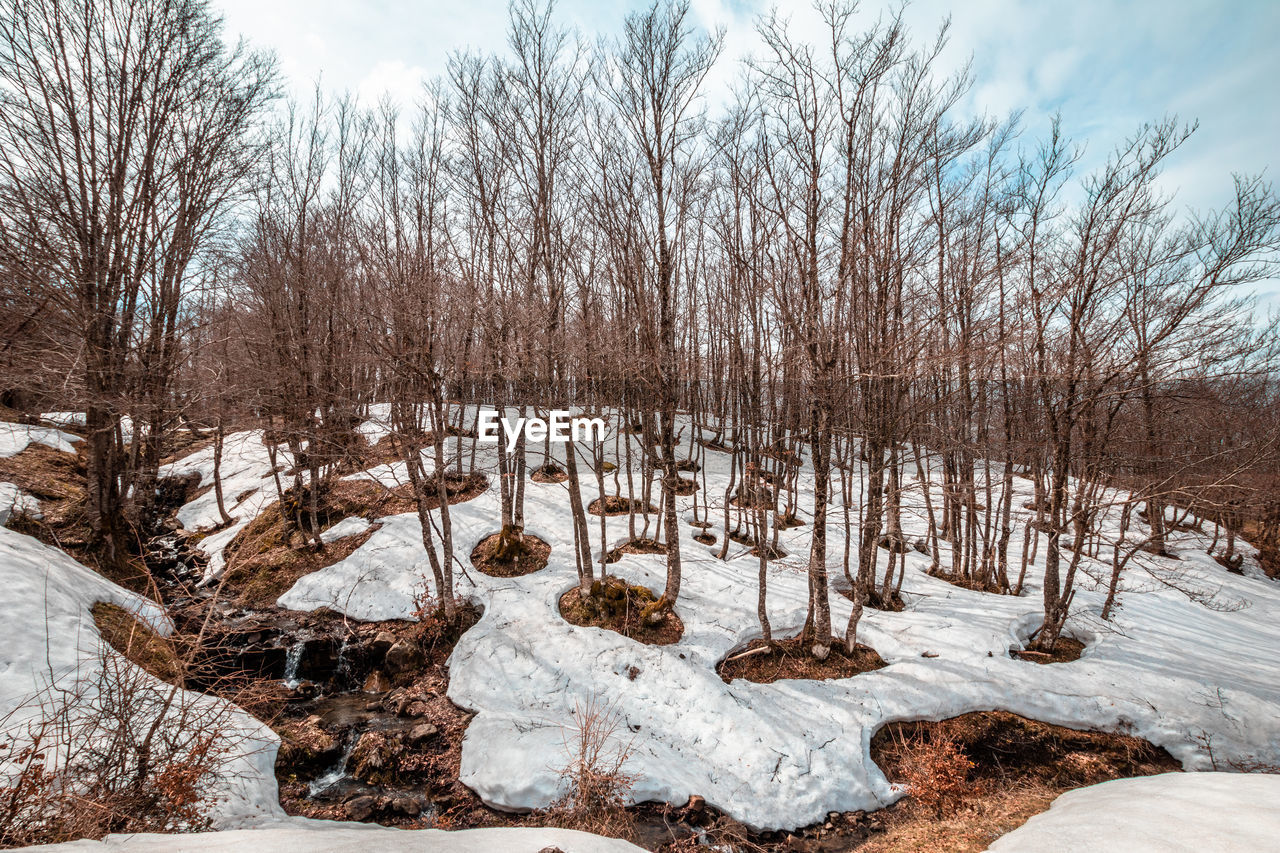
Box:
[238,409,1280,829]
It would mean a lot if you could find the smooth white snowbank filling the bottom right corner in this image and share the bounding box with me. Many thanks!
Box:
[989,772,1280,853]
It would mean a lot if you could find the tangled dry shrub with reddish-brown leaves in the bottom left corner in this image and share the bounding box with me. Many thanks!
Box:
[0,643,242,847]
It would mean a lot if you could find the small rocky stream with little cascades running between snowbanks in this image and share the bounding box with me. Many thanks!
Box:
[142,478,448,825]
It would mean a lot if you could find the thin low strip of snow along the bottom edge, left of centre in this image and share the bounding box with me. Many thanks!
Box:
[29,818,641,853]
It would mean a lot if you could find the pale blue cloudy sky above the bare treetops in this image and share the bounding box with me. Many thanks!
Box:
[211,0,1280,311]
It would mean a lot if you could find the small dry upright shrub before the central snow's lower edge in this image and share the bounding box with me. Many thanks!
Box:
[545,698,636,838]
